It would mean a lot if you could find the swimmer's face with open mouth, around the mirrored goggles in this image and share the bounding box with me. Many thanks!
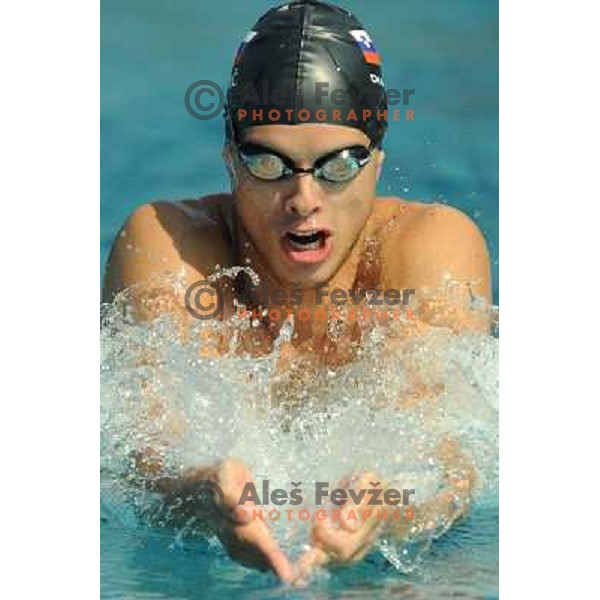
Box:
[225,123,383,288]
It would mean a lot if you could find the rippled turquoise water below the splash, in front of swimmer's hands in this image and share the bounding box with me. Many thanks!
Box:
[101,506,498,600]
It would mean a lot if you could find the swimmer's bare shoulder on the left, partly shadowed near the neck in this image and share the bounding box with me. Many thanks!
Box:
[103,194,233,301]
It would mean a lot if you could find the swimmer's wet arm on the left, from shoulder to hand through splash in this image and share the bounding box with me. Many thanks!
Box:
[103,202,292,581]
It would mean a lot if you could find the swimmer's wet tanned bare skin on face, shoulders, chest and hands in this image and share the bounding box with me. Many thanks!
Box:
[103,124,490,581]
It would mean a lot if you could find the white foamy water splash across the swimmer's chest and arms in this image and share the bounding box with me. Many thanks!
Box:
[101,274,498,572]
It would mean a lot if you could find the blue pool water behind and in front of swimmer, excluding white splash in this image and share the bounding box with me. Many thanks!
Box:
[101,0,499,598]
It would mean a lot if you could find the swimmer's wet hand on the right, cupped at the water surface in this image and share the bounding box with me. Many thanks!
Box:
[293,473,383,585]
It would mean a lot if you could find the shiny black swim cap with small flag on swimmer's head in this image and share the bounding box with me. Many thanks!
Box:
[225,0,387,146]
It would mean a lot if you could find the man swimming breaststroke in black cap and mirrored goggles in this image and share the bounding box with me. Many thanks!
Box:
[103,1,491,582]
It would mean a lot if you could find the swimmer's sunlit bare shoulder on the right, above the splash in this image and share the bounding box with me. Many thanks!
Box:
[375,198,490,299]
